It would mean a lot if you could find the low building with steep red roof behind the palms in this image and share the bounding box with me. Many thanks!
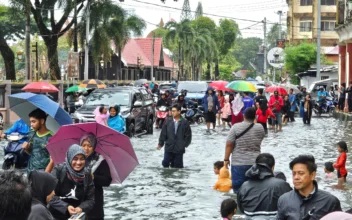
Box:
[79,38,176,81]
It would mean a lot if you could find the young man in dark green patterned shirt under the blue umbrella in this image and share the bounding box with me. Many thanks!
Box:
[22,109,53,173]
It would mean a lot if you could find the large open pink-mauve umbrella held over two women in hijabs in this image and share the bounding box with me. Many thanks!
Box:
[46,122,139,183]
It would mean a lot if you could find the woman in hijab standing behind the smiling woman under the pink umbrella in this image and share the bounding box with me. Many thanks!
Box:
[80,133,112,220]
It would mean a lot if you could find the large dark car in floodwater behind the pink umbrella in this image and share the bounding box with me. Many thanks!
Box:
[73,86,155,137]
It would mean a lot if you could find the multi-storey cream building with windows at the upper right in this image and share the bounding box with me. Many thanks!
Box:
[287,0,339,46]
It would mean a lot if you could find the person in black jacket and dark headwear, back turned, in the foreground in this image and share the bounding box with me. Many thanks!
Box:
[237,153,292,219]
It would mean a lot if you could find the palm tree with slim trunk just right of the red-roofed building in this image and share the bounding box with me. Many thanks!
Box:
[165,19,195,80]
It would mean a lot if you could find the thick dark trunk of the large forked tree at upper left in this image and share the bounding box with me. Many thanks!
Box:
[43,35,61,80]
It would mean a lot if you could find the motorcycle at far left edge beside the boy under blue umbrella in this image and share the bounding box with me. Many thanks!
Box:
[2,132,29,170]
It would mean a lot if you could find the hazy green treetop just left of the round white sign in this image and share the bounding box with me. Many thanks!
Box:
[232,37,263,67]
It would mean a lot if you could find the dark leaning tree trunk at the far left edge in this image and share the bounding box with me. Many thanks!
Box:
[0,36,16,80]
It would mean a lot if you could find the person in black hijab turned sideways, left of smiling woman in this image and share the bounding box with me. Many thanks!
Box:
[28,170,57,220]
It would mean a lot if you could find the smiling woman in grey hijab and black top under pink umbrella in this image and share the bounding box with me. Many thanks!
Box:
[49,144,95,220]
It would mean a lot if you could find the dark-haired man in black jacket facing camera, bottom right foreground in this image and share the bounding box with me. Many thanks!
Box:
[277,155,341,220]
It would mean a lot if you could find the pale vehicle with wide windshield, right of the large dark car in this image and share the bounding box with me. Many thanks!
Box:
[177,81,208,105]
